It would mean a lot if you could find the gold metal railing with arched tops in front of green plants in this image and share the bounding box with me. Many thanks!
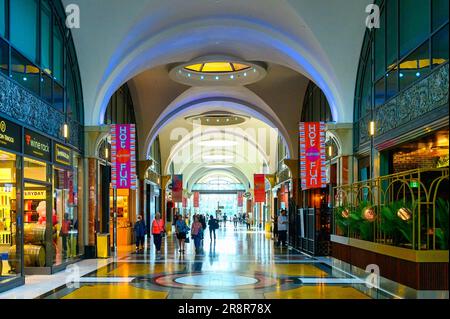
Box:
[333,167,449,250]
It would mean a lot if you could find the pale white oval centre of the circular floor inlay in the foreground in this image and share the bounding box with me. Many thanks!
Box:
[175,274,258,288]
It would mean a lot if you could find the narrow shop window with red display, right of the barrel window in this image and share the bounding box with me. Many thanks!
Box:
[53,168,78,265]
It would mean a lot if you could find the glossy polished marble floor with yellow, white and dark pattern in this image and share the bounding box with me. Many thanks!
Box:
[0,223,442,299]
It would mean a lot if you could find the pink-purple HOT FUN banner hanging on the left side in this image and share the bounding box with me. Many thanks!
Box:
[111,124,136,189]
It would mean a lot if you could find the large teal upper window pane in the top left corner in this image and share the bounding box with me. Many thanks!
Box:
[10,0,38,63]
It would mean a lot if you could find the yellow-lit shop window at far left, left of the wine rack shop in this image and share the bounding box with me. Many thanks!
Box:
[0,151,21,284]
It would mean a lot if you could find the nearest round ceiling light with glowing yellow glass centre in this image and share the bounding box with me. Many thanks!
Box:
[169,56,267,86]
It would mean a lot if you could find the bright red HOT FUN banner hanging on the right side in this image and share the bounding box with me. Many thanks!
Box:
[300,122,327,190]
